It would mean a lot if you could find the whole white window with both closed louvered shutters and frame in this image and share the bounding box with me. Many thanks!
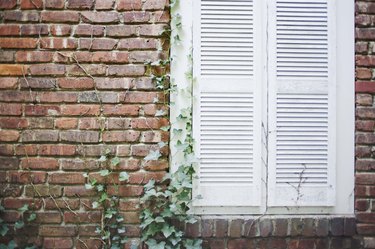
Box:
[172,0,354,214]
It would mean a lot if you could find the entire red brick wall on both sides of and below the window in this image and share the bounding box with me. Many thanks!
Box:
[0,0,375,249]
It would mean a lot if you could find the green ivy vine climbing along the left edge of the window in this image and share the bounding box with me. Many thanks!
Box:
[140,0,202,249]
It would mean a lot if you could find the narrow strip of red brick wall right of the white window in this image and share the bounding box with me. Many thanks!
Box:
[355,1,375,248]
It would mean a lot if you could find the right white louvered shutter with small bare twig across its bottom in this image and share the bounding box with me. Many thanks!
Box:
[268,0,336,206]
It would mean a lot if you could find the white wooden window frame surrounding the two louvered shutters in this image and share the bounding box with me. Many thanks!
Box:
[170,0,355,215]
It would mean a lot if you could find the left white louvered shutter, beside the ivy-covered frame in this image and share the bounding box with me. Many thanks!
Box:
[193,0,261,206]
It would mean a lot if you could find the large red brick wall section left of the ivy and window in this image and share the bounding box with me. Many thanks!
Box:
[0,0,169,248]
